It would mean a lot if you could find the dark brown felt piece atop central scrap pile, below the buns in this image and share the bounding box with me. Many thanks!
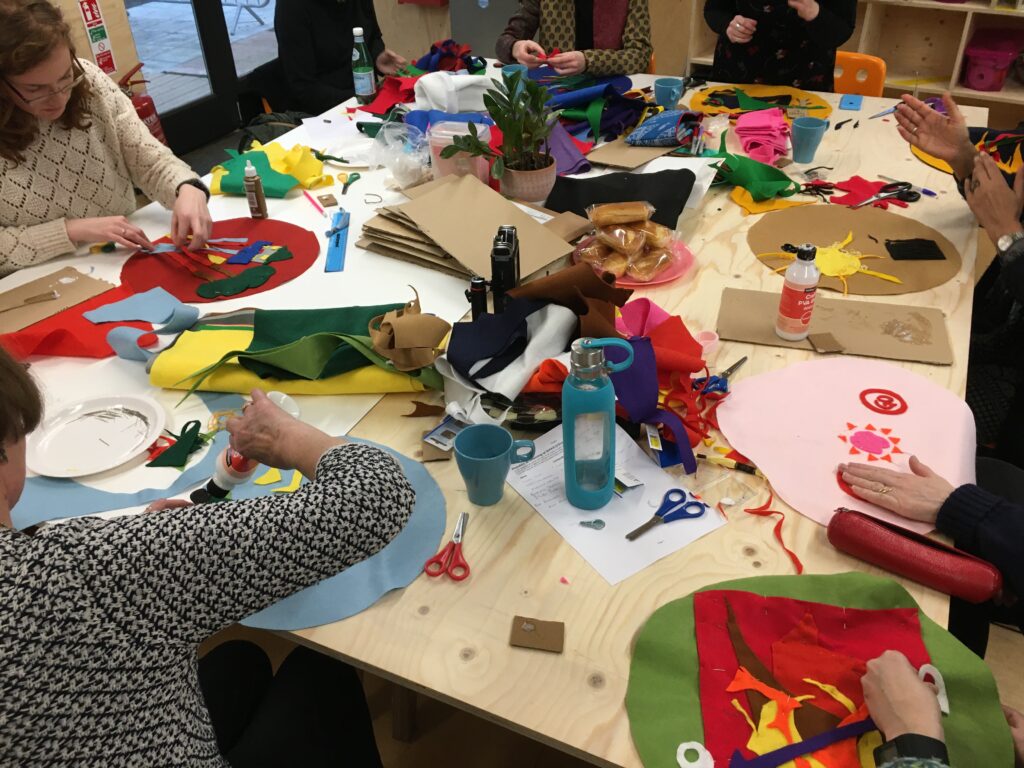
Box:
[509,263,633,339]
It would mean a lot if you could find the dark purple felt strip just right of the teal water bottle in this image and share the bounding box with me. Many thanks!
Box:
[605,336,697,474]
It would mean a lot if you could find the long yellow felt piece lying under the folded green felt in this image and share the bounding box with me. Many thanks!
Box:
[150,329,425,394]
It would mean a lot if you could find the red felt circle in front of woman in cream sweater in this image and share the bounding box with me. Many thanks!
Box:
[121,218,319,303]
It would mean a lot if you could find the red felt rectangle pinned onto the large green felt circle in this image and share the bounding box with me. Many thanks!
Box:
[693,590,930,765]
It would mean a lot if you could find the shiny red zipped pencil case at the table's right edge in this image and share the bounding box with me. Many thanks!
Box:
[828,507,1002,603]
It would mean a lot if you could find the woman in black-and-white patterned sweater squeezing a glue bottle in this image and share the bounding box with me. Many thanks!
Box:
[0,350,415,768]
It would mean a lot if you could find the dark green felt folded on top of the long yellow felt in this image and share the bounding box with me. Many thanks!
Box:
[239,304,404,379]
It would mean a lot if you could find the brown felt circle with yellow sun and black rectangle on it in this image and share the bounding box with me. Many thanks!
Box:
[746,202,961,296]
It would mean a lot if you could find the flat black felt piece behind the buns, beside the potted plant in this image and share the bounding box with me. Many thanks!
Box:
[545,169,696,229]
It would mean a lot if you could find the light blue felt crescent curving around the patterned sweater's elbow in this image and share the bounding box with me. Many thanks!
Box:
[243,438,446,630]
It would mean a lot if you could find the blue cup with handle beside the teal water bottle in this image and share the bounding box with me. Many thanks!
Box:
[455,424,537,507]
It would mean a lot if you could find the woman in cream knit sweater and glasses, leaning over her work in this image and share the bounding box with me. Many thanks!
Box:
[0,0,212,275]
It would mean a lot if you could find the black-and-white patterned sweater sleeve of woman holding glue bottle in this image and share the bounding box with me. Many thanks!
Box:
[37,444,416,644]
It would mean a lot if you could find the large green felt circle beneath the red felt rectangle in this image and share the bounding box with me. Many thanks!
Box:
[626,573,1014,768]
